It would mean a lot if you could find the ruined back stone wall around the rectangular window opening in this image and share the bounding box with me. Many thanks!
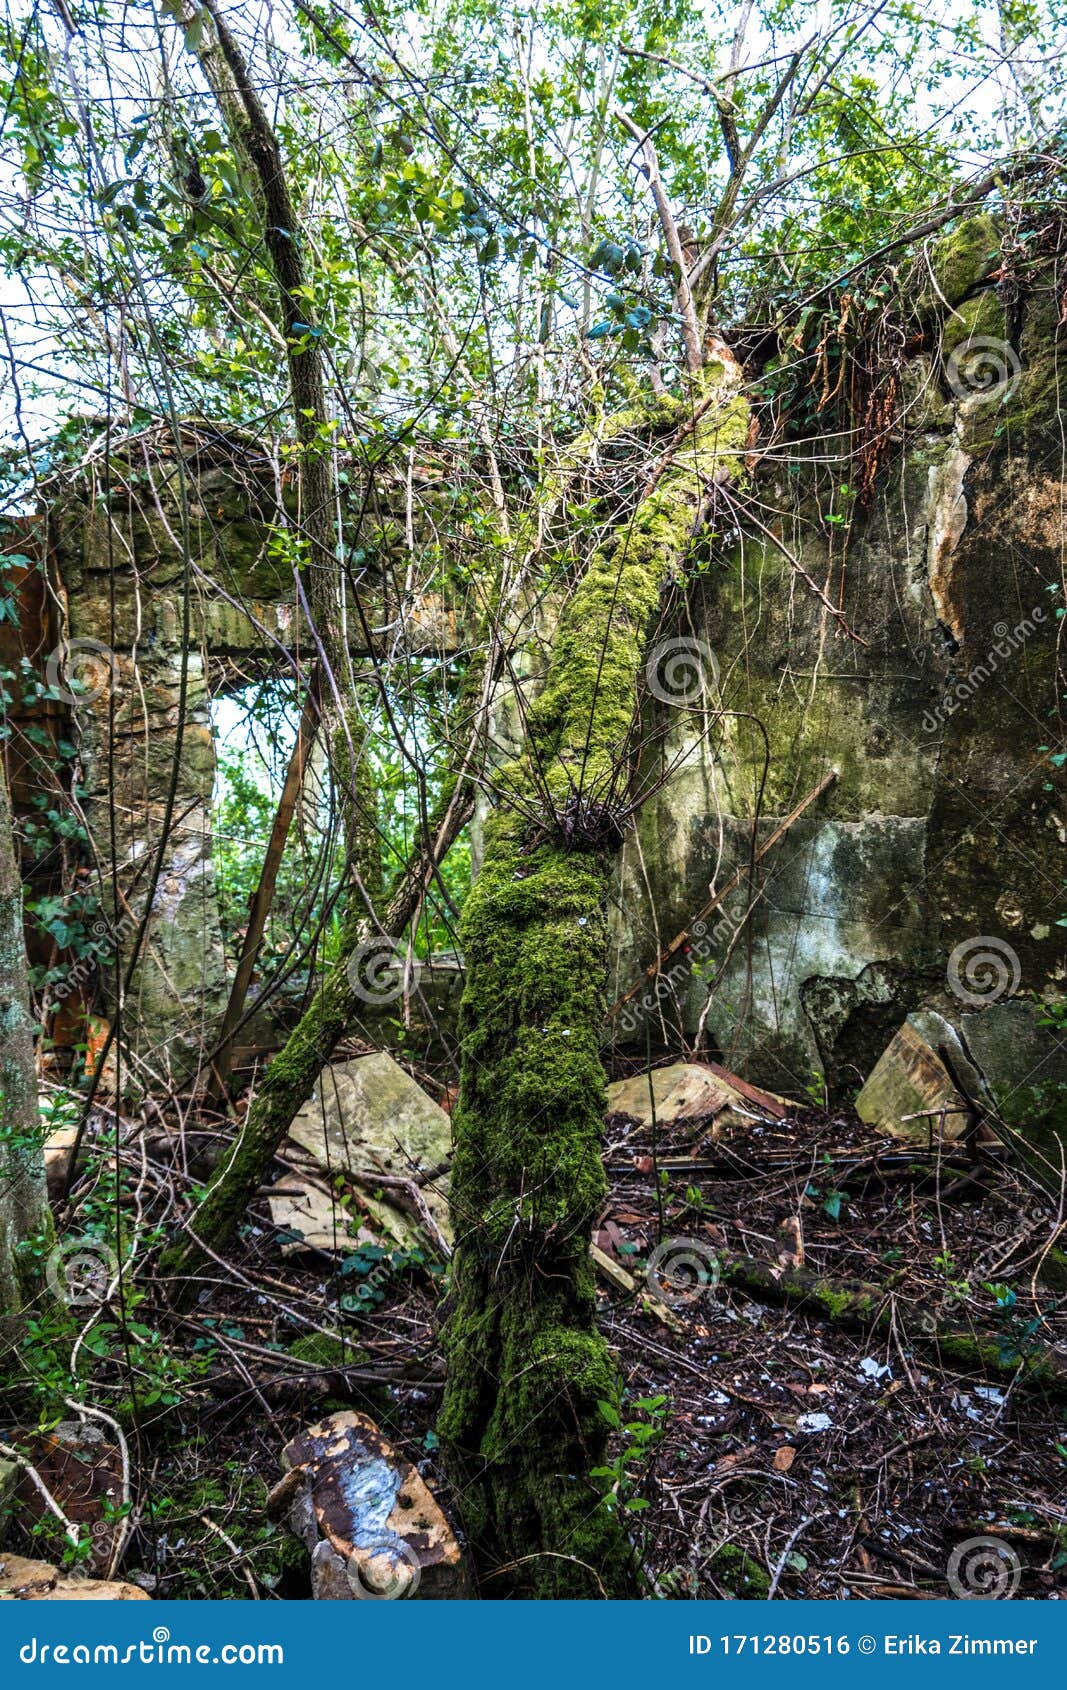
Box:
[40,423,455,1077]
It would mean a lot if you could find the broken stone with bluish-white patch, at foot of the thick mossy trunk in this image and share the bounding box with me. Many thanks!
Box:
[272,1409,470,1600]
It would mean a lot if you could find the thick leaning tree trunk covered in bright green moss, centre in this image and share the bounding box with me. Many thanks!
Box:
[440,365,747,1597]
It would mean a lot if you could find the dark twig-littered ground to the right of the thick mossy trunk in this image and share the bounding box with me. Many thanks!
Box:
[602,1109,1067,1600]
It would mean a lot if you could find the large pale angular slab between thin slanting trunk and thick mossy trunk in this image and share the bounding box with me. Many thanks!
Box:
[289,1051,451,1247]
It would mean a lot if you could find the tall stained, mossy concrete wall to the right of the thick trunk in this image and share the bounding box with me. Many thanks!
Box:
[609,220,1067,1095]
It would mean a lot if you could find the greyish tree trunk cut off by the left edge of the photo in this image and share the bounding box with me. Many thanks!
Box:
[0,769,49,1313]
